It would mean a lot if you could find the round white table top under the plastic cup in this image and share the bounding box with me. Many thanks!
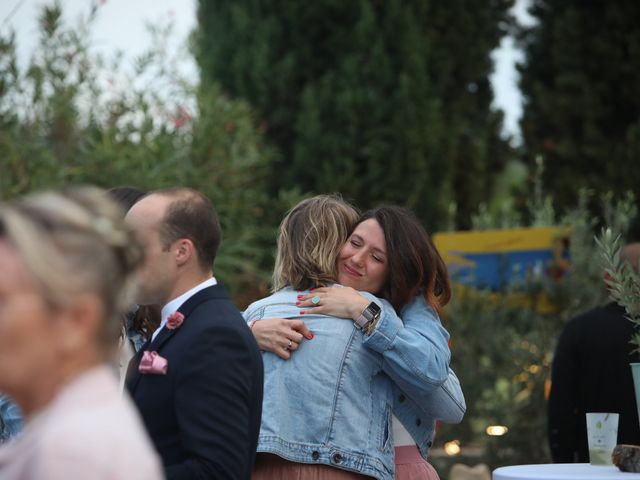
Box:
[493,463,640,480]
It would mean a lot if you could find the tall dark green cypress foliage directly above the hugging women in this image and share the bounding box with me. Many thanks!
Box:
[194,0,513,228]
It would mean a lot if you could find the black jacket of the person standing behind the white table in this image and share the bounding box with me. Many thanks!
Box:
[549,303,640,463]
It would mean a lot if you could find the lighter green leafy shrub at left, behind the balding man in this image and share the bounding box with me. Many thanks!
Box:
[0,4,288,305]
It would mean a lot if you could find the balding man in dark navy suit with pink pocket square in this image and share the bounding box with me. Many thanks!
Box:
[126,188,263,479]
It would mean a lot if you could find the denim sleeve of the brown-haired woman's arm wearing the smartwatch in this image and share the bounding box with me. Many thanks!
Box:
[364,293,451,405]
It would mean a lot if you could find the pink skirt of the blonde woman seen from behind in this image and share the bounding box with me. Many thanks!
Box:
[251,453,371,480]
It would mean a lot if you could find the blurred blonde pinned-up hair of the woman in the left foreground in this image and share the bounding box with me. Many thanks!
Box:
[0,187,144,356]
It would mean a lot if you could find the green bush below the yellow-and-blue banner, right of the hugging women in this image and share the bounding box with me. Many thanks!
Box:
[433,191,636,475]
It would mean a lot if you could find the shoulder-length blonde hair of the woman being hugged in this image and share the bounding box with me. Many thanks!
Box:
[273,195,358,291]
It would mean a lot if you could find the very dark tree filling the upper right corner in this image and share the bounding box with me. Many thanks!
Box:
[519,0,640,229]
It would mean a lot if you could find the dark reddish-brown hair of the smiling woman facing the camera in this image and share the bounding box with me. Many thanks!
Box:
[358,206,451,312]
